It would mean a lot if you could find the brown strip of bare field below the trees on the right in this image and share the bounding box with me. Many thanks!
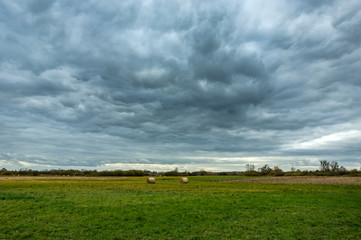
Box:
[224,176,361,185]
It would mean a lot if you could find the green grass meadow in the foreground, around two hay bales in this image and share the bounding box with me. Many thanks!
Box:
[0,177,361,239]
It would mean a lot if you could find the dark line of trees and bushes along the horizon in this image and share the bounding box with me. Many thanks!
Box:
[0,160,361,177]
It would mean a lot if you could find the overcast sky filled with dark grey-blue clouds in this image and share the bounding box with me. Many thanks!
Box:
[0,0,361,171]
